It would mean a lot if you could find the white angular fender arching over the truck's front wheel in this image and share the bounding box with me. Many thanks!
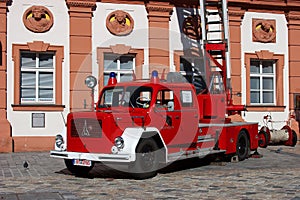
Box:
[120,127,168,161]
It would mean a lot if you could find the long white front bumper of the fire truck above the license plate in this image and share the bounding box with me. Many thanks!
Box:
[50,150,135,163]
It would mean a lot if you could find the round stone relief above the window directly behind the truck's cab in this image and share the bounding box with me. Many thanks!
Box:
[106,10,134,36]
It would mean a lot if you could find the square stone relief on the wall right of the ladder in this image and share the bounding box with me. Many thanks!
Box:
[252,19,276,43]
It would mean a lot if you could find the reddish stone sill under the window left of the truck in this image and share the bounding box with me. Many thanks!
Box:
[11,104,65,112]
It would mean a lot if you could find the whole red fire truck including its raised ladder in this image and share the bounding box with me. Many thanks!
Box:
[50,0,263,178]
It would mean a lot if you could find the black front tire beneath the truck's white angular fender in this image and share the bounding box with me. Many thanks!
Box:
[130,138,161,179]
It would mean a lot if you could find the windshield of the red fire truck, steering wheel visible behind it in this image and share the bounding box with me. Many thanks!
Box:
[98,86,152,108]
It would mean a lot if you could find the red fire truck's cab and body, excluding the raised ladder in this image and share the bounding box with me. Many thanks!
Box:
[51,73,258,177]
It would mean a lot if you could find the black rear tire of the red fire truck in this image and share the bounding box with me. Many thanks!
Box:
[236,130,250,161]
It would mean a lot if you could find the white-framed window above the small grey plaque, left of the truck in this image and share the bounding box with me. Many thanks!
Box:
[20,51,55,103]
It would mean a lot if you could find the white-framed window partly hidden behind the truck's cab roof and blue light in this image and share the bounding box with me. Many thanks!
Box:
[103,53,135,85]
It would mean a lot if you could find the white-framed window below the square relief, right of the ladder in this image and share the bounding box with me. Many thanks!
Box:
[250,59,276,105]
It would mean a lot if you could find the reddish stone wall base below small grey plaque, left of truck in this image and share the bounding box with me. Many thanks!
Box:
[13,136,55,152]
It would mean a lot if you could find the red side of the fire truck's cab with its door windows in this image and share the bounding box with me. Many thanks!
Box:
[156,89,198,153]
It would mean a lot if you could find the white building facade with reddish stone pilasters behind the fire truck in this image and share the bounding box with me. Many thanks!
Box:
[0,0,300,152]
